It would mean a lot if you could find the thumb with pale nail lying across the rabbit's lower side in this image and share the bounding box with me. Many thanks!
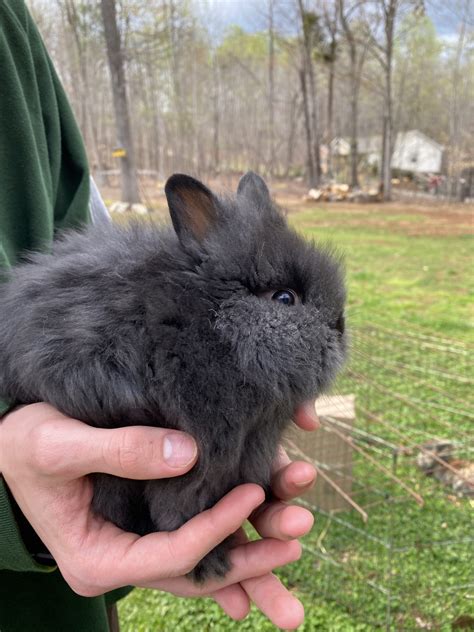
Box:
[32,417,197,480]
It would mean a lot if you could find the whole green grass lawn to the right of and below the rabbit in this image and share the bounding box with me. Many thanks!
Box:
[119,203,474,632]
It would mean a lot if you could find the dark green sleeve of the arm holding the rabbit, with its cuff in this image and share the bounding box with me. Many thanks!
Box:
[0,0,90,572]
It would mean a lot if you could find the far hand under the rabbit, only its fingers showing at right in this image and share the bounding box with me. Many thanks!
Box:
[104,401,320,629]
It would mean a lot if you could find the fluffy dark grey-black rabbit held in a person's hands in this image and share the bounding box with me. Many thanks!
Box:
[0,174,346,582]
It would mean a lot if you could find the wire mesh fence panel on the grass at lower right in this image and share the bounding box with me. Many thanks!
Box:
[287,325,474,630]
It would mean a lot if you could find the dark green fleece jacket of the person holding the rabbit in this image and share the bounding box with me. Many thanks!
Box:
[0,0,128,632]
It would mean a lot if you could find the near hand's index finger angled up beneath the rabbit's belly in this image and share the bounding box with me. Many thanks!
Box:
[114,484,264,589]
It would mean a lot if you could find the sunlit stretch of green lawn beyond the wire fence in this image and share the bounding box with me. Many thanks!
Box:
[292,211,474,338]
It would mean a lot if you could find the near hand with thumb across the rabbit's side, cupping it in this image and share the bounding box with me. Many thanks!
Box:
[0,404,300,624]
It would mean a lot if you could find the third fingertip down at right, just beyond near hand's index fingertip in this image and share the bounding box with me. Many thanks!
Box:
[251,502,314,540]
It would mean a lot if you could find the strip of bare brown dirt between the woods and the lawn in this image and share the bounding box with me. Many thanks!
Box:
[100,176,474,236]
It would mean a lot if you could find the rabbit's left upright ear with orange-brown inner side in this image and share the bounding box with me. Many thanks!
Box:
[165,173,218,246]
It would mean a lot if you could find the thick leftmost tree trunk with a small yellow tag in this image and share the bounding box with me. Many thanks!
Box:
[100,0,140,204]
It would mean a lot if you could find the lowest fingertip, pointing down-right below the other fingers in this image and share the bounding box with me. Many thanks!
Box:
[242,574,304,630]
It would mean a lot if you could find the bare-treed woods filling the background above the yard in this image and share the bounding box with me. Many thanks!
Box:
[30,0,474,202]
